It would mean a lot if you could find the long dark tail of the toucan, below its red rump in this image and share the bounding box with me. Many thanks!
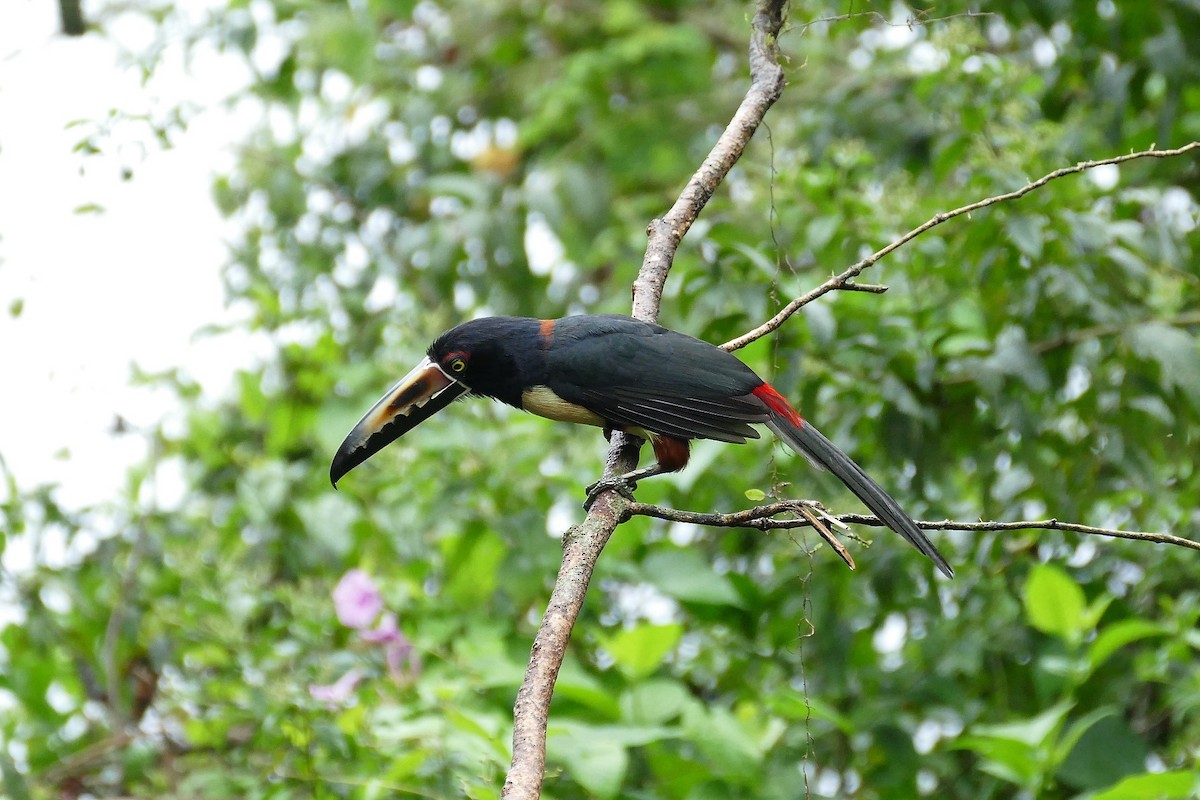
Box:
[767,405,954,578]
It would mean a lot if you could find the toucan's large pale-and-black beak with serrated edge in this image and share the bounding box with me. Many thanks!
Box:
[329,356,468,488]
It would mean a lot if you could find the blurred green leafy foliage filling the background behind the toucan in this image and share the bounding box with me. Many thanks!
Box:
[0,0,1200,800]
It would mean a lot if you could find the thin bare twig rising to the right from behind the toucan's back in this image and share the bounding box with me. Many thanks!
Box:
[721,142,1200,350]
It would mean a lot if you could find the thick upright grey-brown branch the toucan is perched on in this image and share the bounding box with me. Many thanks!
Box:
[502,0,786,800]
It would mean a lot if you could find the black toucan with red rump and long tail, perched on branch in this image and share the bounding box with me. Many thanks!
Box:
[329,314,954,577]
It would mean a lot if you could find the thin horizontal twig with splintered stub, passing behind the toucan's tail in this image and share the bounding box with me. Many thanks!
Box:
[625,500,1200,554]
